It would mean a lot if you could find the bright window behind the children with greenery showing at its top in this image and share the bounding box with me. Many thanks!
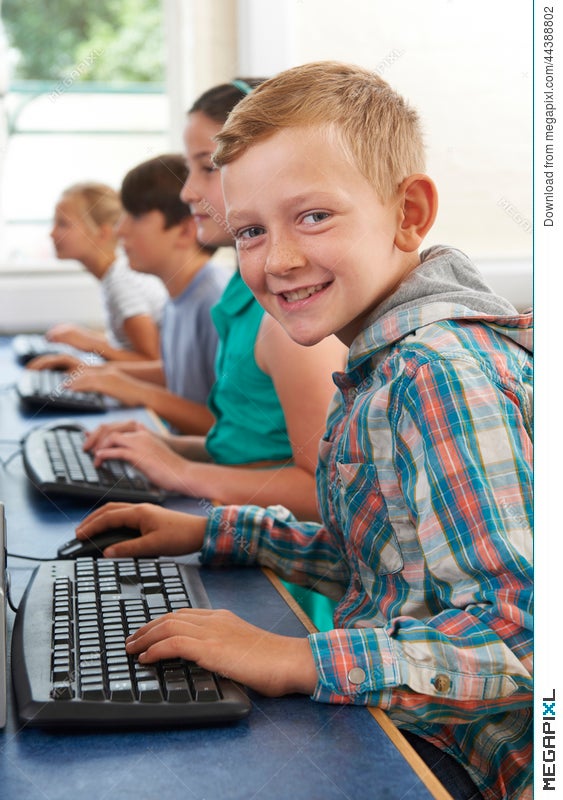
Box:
[0,0,169,269]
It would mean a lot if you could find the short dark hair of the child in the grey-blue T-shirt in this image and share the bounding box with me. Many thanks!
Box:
[121,153,191,228]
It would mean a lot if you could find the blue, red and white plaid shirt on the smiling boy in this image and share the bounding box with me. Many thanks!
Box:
[202,260,532,800]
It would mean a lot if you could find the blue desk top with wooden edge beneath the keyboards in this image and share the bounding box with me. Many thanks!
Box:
[0,339,449,800]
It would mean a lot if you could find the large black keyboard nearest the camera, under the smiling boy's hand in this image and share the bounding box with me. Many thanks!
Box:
[12,558,250,726]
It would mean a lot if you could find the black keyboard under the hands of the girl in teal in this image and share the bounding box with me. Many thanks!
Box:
[22,422,166,503]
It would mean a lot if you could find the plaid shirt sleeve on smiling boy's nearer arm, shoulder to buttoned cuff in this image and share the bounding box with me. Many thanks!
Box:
[310,361,532,723]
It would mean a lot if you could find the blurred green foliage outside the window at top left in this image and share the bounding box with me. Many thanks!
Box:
[2,0,164,83]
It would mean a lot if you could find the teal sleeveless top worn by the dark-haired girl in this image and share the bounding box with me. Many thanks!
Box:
[205,271,292,464]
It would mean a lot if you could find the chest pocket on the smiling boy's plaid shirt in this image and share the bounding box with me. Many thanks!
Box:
[337,463,403,588]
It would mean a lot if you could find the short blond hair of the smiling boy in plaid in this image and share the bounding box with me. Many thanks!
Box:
[213,61,425,201]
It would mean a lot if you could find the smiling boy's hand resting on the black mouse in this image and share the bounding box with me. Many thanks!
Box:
[76,503,207,558]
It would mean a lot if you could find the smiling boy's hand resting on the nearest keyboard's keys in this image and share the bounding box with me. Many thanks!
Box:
[127,608,317,697]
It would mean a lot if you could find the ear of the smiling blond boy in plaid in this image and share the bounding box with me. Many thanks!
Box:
[395,173,438,253]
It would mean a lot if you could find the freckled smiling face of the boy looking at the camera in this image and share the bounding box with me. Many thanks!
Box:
[222,128,413,345]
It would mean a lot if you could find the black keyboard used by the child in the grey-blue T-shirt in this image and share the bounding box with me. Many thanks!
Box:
[16,369,107,413]
